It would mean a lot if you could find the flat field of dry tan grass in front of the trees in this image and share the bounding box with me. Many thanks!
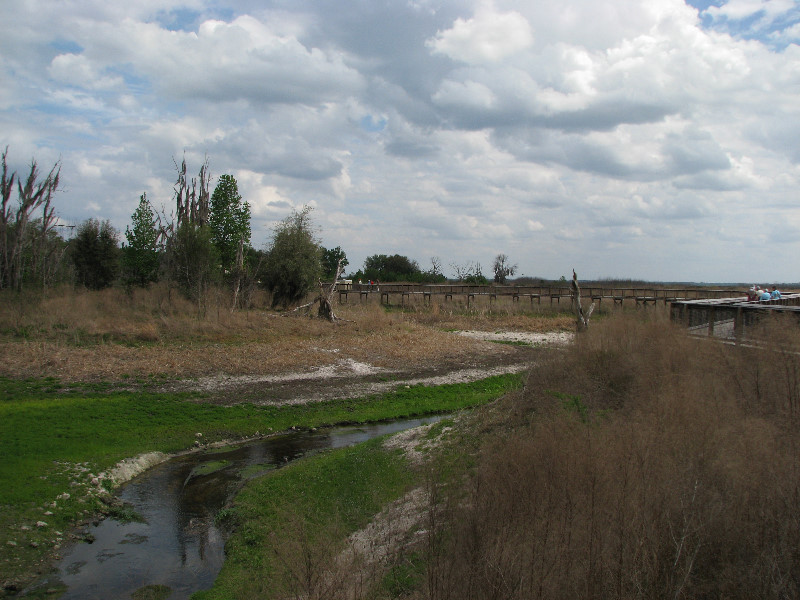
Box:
[0,287,544,381]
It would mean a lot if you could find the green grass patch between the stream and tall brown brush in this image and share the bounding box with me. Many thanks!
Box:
[193,438,414,600]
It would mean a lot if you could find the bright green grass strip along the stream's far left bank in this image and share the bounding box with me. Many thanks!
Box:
[0,375,521,578]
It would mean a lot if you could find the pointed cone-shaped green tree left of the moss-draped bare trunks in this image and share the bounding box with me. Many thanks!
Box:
[122,194,160,287]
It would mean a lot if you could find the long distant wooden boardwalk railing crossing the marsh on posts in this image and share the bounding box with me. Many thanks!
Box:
[337,283,739,306]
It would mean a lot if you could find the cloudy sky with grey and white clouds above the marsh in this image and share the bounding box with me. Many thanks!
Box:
[0,0,800,283]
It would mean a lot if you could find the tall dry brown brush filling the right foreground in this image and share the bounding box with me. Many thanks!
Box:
[419,318,800,599]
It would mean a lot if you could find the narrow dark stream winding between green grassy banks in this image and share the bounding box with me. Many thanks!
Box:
[32,417,438,600]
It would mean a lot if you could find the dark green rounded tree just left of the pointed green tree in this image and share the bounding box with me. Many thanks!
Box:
[70,219,119,290]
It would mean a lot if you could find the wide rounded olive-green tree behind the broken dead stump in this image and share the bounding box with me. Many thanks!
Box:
[264,206,322,308]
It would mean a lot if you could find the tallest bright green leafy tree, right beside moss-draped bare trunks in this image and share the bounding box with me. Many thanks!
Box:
[208,175,250,274]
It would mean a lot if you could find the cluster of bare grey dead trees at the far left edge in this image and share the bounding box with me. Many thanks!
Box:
[0,148,61,289]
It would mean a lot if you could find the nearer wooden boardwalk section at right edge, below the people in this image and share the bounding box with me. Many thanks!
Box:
[670,294,800,341]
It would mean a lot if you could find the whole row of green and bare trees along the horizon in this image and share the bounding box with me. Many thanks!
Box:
[0,149,516,308]
